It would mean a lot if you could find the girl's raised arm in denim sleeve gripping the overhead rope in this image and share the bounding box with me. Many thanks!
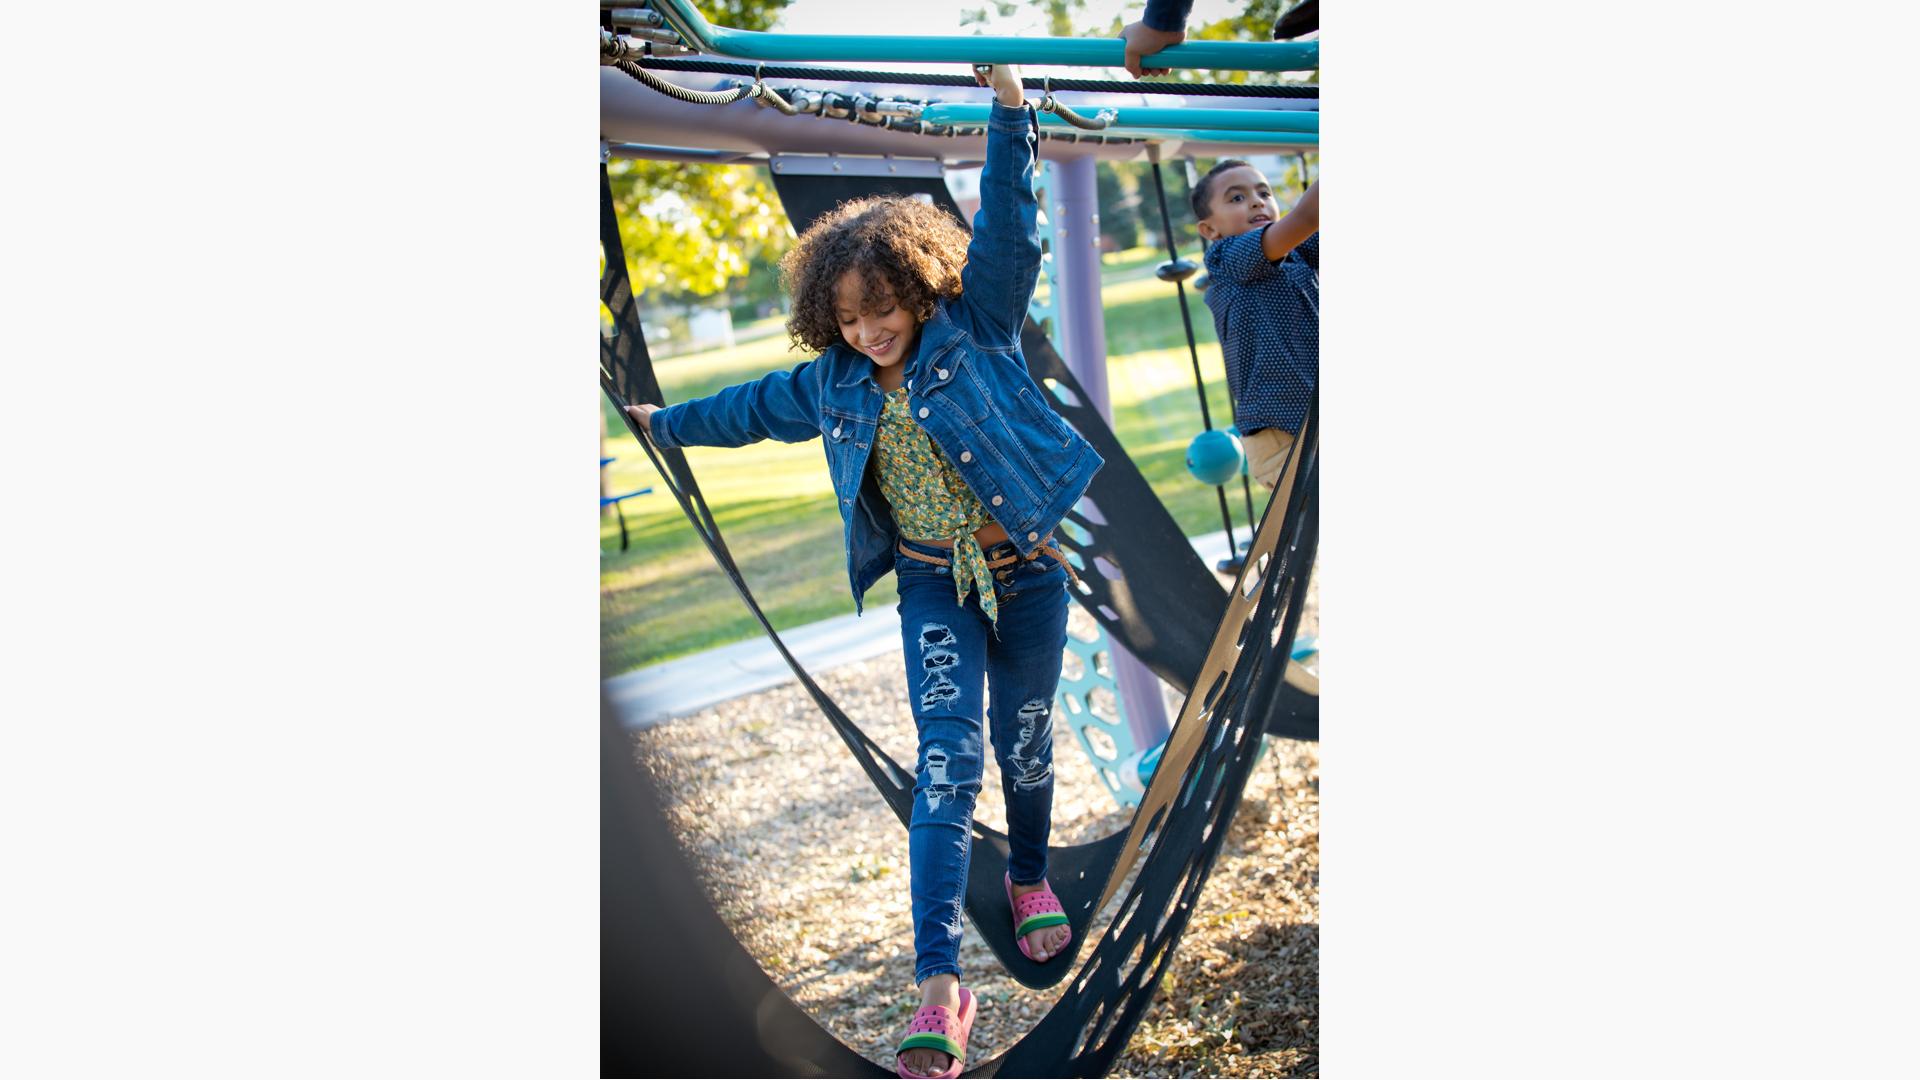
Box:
[960,63,1041,346]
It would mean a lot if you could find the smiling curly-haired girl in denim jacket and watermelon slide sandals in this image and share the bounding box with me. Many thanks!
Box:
[630,65,1102,1076]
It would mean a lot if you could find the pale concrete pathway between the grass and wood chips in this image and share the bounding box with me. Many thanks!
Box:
[601,525,1248,730]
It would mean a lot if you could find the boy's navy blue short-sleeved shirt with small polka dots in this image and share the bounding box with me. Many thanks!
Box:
[1206,225,1319,434]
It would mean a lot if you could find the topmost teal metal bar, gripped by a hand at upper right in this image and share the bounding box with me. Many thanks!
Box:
[649,0,1319,71]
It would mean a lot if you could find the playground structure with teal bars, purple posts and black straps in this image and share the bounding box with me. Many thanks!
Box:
[601,0,1319,1076]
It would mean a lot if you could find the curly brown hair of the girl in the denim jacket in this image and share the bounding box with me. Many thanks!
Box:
[780,194,968,352]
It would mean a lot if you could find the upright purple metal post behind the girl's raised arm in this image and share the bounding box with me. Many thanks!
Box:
[1046,154,1171,749]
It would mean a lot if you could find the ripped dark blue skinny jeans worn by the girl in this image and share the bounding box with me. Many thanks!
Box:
[893,542,1068,982]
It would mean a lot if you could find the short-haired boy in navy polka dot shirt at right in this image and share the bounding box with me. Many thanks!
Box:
[1192,158,1319,488]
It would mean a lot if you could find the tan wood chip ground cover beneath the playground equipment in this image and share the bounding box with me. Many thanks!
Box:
[634,588,1319,1076]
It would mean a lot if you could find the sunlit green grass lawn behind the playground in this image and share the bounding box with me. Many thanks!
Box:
[601,263,1246,676]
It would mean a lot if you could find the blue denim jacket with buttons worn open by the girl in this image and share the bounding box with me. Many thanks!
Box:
[649,102,1104,611]
